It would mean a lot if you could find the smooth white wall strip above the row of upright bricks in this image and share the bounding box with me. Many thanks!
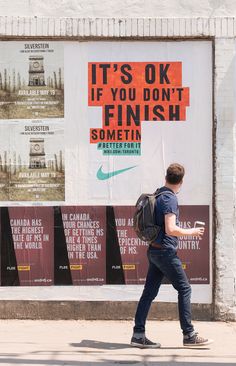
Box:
[0,0,236,18]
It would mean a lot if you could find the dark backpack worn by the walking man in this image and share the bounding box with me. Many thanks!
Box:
[133,189,173,242]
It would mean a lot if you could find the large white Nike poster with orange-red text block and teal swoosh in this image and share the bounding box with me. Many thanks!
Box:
[65,41,212,209]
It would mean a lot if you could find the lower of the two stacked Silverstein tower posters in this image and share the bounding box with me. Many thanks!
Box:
[9,120,65,201]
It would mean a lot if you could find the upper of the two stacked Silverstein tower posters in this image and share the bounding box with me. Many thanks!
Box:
[0,41,64,120]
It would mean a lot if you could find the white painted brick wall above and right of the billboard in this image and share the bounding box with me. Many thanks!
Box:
[0,1,236,320]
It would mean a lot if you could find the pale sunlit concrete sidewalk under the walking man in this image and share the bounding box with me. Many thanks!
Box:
[0,320,236,366]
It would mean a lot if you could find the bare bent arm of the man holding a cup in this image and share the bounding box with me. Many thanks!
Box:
[165,213,205,236]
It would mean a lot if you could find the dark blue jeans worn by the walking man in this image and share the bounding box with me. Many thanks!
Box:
[134,247,194,335]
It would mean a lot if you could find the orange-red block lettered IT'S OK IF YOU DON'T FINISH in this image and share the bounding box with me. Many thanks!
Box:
[88,62,189,148]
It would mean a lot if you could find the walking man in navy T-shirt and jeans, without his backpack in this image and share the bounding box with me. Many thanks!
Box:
[131,164,212,348]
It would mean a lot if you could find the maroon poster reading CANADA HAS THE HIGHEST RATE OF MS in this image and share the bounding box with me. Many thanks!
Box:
[9,207,54,286]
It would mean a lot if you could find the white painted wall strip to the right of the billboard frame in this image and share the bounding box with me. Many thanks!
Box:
[214,38,236,320]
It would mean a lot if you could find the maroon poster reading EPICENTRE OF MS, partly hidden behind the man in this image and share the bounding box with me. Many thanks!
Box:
[114,206,148,284]
